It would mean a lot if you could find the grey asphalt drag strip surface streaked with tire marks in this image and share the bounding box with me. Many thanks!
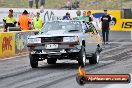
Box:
[0,32,132,88]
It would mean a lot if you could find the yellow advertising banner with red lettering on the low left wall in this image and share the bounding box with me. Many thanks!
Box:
[0,32,15,58]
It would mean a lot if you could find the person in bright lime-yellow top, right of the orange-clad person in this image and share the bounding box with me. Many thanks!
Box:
[33,12,43,30]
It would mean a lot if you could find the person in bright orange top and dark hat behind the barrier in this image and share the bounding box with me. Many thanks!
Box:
[18,10,31,30]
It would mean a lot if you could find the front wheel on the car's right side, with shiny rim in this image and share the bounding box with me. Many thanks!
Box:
[78,46,86,67]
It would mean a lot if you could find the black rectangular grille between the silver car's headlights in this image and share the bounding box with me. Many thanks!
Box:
[41,37,63,43]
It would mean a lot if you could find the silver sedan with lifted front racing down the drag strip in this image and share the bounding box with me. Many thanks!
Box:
[27,20,102,68]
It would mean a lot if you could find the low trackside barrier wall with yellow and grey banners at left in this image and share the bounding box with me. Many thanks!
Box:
[0,31,38,58]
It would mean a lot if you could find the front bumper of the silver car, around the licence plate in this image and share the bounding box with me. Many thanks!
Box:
[28,42,81,55]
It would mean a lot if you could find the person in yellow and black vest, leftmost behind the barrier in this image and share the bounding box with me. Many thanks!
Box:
[3,9,17,32]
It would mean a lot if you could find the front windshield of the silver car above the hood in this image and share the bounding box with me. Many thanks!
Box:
[41,21,82,33]
